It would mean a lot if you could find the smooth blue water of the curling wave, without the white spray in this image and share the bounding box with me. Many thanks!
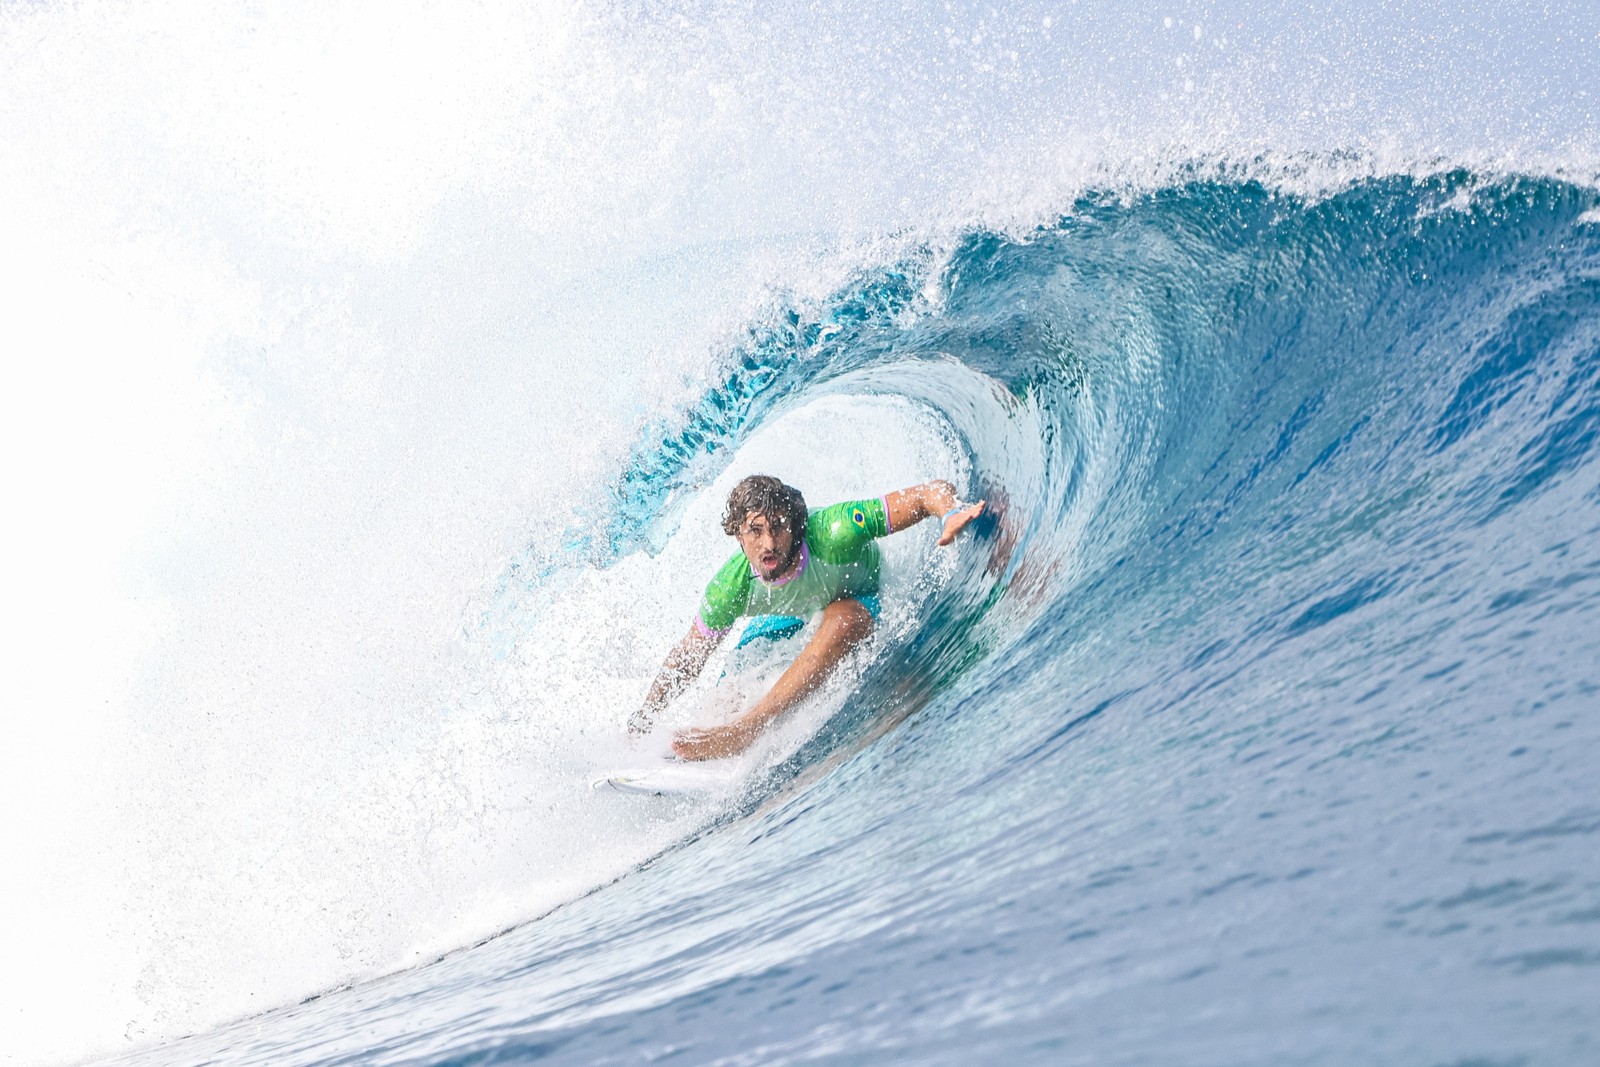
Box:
[100,171,1600,1064]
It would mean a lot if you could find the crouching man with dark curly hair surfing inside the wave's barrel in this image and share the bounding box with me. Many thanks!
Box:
[627,475,984,760]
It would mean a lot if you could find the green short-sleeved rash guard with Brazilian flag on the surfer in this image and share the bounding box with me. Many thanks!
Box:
[694,498,893,637]
